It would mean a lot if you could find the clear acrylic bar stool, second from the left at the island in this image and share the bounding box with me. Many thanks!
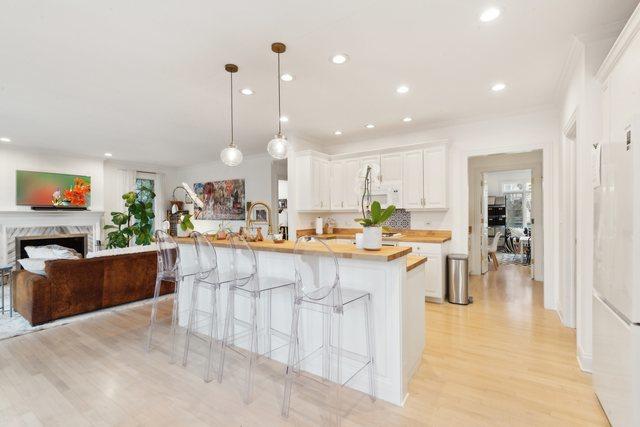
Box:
[182,231,220,382]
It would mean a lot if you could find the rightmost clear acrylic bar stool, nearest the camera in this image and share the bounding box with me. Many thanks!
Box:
[282,236,376,420]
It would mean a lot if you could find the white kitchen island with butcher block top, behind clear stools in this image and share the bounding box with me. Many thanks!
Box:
[176,238,426,405]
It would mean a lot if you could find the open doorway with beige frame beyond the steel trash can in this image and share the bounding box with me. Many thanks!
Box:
[468,150,544,282]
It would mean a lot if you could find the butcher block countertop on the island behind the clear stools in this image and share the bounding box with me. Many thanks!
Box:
[174,237,411,262]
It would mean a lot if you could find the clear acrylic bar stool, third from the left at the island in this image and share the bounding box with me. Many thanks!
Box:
[218,233,294,403]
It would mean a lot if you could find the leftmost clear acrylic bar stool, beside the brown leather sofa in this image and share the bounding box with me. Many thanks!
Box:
[146,230,197,363]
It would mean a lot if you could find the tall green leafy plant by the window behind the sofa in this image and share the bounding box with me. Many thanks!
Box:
[104,187,156,249]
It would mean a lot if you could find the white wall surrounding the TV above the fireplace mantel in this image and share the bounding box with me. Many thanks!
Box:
[0,144,104,211]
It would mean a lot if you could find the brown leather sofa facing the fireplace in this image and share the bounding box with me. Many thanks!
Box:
[13,252,173,325]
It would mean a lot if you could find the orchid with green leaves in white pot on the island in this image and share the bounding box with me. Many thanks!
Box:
[355,165,396,251]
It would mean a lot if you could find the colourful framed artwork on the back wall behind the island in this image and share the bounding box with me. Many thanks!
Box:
[193,179,246,220]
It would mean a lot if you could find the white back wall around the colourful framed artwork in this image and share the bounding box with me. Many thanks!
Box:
[169,154,277,232]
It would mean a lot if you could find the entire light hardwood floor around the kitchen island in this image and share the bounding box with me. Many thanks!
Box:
[0,265,607,426]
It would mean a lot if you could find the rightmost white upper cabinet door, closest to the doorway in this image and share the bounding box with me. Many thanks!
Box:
[424,146,448,209]
